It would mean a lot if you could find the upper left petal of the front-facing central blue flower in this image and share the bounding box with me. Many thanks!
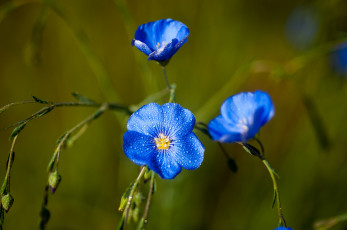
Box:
[127,103,163,136]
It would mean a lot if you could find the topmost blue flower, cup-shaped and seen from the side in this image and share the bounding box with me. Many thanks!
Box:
[131,18,189,63]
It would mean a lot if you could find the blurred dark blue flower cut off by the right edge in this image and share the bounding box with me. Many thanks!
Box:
[331,42,347,76]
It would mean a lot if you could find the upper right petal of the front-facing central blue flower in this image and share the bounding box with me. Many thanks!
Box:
[161,103,195,139]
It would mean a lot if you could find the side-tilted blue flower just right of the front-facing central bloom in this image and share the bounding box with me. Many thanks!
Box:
[208,91,275,143]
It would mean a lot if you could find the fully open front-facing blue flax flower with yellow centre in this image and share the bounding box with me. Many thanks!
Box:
[123,103,205,179]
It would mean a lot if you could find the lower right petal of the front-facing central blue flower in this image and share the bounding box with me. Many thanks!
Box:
[170,133,205,170]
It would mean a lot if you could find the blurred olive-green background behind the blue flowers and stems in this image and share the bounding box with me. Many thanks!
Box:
[0,0,347,230]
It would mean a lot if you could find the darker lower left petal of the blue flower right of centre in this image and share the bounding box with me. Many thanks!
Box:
[208,115,247,143]
